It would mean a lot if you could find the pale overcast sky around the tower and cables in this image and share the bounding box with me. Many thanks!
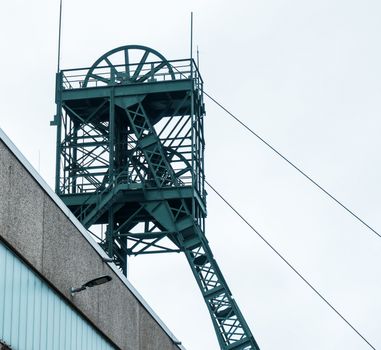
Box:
[0,0,381,350]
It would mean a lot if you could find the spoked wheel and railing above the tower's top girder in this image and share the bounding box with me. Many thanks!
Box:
[57,45,203,92]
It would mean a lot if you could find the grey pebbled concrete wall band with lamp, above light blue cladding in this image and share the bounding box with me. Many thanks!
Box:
[0,129,184,350]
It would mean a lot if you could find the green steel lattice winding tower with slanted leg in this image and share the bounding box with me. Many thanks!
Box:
[52,45,259,349]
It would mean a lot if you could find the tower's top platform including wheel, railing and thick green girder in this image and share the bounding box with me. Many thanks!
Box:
[57,45,203,123]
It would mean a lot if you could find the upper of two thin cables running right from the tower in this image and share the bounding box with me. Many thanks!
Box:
[203,91,381,238]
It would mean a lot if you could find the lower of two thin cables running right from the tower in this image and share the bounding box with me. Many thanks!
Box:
[204,179,376,350]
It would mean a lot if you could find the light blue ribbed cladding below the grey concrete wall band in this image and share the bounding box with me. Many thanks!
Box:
[0,242,114,350]
